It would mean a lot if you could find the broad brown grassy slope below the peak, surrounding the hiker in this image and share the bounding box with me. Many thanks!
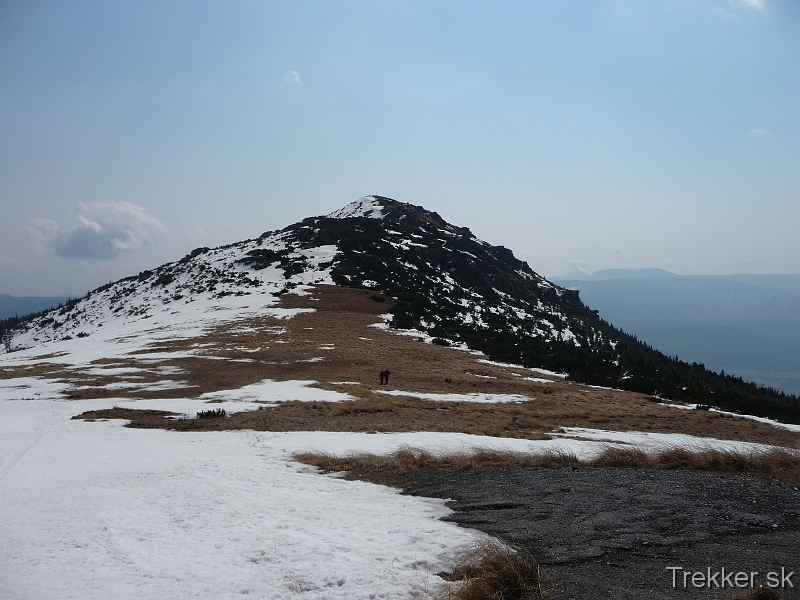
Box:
[18,286,800,449]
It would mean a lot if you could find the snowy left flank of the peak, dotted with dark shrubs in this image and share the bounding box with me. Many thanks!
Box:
[0,232,337,352]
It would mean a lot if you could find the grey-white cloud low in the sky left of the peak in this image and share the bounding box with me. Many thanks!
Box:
[28,202,166,260]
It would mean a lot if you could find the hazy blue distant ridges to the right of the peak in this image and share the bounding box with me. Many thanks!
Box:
[556,269,800,394]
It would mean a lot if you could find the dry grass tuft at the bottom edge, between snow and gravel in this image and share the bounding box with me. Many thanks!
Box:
[435,540,552,600]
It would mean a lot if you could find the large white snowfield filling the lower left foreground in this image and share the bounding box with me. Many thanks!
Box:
[0,390,792,600]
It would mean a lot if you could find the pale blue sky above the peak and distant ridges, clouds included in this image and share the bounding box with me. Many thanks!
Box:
[0,0,800,295]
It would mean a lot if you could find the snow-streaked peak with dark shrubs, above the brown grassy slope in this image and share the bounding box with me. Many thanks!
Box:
[0,196,800,421]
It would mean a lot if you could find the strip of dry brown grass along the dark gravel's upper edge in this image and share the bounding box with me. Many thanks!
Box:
[295,447,800,489]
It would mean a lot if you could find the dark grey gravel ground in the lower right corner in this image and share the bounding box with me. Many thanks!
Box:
[412,468,800,600]
